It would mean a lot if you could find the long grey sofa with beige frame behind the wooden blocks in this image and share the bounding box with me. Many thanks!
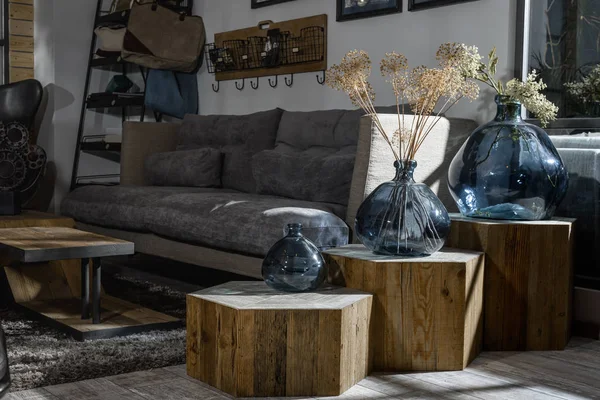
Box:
[61,109,476,277]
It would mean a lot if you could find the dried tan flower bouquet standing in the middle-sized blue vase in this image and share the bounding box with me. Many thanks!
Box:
[326,45,479,161]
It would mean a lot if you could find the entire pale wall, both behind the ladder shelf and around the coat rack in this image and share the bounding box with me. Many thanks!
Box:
[35,0,516,209]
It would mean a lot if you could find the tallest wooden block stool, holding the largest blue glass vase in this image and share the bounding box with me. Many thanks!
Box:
[447,214,575,351]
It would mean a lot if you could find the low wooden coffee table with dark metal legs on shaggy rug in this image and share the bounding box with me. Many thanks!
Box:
[0,227,181,340]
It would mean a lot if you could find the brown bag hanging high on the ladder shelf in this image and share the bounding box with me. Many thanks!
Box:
[121,0,206,73]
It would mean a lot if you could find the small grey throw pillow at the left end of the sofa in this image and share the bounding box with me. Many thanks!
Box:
[144,147,222,187]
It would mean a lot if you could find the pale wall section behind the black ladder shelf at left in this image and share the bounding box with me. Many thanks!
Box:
[35,0,138,211]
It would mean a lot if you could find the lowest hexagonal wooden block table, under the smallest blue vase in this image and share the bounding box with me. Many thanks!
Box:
[187,282,373,397]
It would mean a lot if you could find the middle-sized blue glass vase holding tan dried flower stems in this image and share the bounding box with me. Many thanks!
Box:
[354,160,450,257]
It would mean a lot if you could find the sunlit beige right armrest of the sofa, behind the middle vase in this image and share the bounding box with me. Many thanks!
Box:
[346,114,477,234]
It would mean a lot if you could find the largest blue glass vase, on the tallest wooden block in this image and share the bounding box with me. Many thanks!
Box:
[448,96,568,221]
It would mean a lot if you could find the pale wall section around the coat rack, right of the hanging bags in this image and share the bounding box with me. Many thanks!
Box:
[196,0,516,122]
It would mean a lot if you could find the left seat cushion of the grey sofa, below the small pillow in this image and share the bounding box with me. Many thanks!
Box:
[61,186,231,232]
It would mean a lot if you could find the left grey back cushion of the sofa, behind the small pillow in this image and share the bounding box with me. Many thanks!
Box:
[177,108,283,191]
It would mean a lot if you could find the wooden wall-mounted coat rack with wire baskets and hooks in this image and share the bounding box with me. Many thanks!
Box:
[205,14,327,92]
